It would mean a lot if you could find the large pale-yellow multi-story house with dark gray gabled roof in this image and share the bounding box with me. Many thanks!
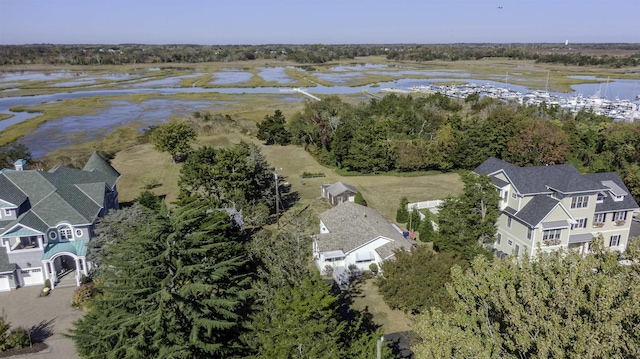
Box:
[474,157,639,257]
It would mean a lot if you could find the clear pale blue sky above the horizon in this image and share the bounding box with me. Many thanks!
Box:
[0,0,640,45]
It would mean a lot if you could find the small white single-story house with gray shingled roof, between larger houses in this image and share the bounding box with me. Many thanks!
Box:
[313,201,414,284]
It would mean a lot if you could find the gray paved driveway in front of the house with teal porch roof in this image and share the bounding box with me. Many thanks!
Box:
[0,286,83,359]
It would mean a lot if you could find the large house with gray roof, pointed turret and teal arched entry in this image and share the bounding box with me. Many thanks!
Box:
[0,152,120,291]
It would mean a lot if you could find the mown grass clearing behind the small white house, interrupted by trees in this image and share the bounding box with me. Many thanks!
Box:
[112,132,462,224]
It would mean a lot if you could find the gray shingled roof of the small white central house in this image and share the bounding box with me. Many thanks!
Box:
[316,202,411,258]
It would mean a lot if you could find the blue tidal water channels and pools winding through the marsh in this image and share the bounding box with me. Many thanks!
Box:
[0,64,640,157]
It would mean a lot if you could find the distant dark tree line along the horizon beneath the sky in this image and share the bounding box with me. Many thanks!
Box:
[0,44,640,67]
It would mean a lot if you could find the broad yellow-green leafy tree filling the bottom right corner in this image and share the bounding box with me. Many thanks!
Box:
[413,237,640,359]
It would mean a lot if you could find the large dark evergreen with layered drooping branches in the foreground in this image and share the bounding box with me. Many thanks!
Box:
[71,202,252,358]
